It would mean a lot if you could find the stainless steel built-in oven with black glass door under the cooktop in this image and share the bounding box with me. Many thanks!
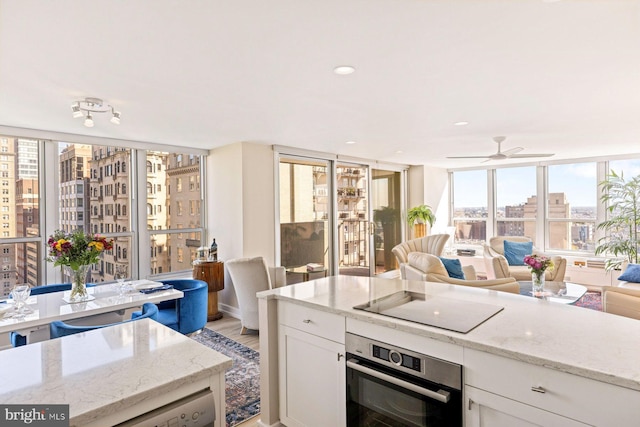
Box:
[346,334,462,427]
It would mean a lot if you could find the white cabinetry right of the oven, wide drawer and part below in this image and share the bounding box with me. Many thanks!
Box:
[464,349,640,427]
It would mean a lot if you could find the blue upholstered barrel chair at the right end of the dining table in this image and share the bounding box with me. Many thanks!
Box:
[131,279,208,335]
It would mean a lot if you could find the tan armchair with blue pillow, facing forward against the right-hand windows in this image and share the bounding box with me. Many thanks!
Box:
[484,236,567,282]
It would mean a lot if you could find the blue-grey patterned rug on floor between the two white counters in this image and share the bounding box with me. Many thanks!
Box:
[192,328,260,427]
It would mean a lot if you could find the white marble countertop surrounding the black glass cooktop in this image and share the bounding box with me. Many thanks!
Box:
[258,276,640,390]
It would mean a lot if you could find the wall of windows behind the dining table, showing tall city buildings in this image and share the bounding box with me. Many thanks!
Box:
[0,132,204,295]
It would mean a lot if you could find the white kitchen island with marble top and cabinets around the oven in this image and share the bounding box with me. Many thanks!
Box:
[258,276,640,426]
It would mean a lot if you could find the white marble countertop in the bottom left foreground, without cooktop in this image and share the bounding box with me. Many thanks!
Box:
[0,319,232,425]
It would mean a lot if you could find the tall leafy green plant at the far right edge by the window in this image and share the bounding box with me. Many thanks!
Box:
[595,171,640,271]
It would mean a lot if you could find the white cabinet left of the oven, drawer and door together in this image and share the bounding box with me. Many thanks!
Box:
[278,301,346,427]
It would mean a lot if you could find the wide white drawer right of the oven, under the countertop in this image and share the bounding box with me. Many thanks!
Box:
[464,349,640,426]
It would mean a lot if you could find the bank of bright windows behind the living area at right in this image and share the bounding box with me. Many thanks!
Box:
[450,159,640,254]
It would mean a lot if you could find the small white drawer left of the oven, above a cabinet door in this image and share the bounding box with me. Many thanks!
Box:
[278,301,345,344]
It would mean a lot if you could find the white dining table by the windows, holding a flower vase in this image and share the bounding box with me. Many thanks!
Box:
[0,279,184,349]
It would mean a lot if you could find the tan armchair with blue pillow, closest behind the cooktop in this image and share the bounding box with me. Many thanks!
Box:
[400,252,520,294]
